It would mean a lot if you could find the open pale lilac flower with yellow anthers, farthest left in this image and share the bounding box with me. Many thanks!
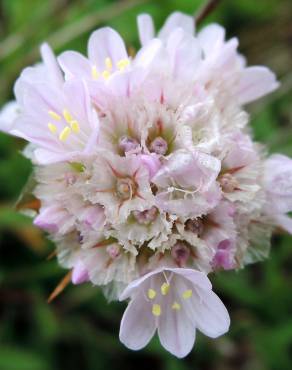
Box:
[10,81,99,164]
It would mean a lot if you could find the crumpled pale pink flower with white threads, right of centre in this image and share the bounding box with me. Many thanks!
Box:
[152,150,221,217]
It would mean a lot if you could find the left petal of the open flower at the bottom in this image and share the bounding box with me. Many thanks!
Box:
[120,294,156,350]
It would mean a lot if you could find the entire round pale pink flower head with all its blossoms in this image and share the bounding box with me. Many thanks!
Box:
[0,12,292,357]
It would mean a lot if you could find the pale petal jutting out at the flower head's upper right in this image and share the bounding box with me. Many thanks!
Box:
[237,66,279,104]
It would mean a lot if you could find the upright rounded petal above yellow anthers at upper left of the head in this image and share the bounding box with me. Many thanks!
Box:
[88,27,128,71]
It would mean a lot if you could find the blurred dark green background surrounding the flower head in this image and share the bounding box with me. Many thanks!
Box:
[0,0,292,370]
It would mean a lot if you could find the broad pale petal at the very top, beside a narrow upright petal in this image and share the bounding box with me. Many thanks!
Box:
[158,12,195,39]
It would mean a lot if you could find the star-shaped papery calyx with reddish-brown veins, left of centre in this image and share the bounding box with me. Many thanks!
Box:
[81,152,154,223]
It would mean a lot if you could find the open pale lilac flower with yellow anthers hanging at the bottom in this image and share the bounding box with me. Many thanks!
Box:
[120,268,230,358]
